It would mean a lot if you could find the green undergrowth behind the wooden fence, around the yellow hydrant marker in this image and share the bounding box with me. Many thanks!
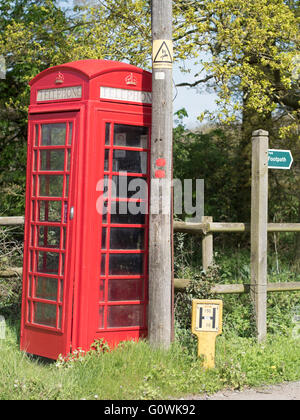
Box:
[175,242,300,344]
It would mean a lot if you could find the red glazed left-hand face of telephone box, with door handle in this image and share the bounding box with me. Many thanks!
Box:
[21,112,79,358]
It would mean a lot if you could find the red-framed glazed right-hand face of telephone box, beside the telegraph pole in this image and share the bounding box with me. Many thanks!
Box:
[98,112,150,346]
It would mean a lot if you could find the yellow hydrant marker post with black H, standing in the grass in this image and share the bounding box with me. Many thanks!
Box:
[192,299,223,369]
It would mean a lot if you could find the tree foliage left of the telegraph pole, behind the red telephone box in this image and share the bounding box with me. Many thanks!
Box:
[0,0,149,214]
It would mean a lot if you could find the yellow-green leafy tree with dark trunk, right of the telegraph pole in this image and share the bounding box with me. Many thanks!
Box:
[86,0,300,221]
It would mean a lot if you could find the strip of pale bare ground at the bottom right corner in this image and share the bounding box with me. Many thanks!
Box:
[191,381,300,401]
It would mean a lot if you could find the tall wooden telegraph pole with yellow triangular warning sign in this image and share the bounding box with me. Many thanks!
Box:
[148,0,173,348]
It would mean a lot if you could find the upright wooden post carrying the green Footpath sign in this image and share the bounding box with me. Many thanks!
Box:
[251,130,269,342]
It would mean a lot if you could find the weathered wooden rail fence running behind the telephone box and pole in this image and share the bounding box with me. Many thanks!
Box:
[0,216,300,294]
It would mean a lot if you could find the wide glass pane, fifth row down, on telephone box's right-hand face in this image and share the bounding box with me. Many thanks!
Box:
[110,227,145,249]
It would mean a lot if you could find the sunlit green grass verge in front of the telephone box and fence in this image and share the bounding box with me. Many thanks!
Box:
[0,318,300,400]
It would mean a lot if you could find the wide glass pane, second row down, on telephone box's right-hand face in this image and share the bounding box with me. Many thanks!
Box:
[113,150,147,174]
